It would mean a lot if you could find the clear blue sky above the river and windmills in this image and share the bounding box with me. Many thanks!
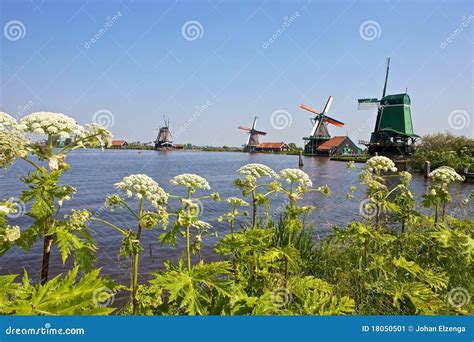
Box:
[0,0,474,146]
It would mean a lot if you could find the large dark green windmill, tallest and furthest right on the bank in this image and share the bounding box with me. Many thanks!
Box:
[359,58,419,156]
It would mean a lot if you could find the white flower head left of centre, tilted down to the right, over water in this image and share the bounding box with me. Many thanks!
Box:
[115,174,168,209]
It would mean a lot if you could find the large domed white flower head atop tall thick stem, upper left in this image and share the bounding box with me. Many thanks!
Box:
[19,112,86,138]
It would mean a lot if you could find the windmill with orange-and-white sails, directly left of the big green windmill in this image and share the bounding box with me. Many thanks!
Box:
[300,96,344,154]
